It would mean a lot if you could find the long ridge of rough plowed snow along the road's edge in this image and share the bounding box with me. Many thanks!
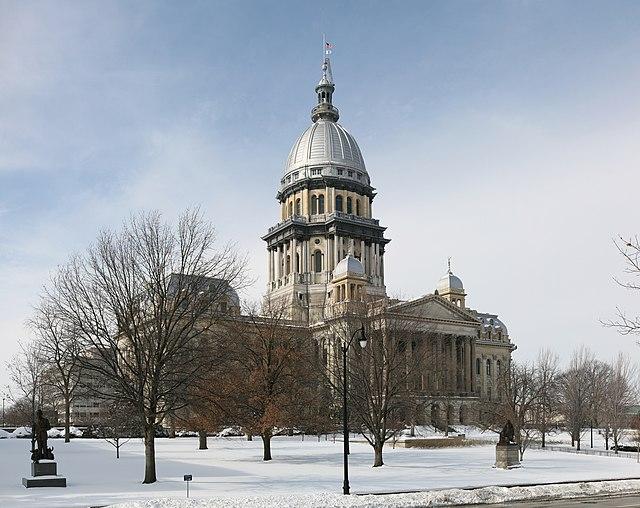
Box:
[110,480,640,508]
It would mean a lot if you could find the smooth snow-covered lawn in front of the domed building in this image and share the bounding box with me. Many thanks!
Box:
[0,437,640,507]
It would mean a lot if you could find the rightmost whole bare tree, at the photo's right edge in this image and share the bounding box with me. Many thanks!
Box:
[604,353,637,453]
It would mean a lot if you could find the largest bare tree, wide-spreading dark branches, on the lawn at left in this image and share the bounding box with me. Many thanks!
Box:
[47,211,244,483]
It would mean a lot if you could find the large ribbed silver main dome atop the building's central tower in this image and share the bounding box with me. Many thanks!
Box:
[284,119,367,176]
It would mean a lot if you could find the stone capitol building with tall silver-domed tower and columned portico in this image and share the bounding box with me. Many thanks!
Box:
[262,57,516,423]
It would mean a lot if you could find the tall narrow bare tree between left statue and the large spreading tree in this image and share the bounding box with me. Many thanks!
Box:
[29,298,80,443]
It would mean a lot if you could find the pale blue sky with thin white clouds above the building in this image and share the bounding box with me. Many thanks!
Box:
[0,0,640,391]
